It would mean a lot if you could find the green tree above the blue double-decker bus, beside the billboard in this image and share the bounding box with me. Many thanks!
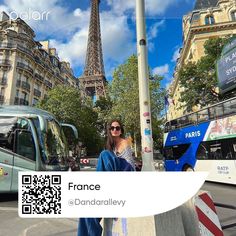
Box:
[179,38,229,111]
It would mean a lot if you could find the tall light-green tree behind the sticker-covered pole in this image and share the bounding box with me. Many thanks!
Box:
[109,55,164,151]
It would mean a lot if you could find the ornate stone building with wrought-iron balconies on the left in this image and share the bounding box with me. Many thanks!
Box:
[0,12,77,105]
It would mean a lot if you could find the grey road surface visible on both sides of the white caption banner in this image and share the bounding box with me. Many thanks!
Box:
[0,180,236,236]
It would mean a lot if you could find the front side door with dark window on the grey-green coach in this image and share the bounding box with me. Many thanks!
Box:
[11,118,36,191]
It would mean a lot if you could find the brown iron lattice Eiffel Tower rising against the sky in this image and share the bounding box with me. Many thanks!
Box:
[79,0,106,100]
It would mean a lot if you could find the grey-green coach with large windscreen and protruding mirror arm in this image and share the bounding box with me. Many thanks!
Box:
[0,106,78,192]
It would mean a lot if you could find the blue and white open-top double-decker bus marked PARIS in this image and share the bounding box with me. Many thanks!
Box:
[164,98,236,184]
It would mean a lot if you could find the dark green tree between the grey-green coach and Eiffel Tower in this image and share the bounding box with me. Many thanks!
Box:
[37,85,102,153]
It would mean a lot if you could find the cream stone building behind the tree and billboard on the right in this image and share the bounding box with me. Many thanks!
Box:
[168,0,236,120]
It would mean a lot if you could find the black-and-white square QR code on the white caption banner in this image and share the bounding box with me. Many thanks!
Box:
[22,175,61,214]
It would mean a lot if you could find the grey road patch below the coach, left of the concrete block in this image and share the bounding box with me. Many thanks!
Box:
[0,194,78,236]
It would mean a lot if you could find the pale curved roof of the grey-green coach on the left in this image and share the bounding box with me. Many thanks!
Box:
[0,105,55,119]
